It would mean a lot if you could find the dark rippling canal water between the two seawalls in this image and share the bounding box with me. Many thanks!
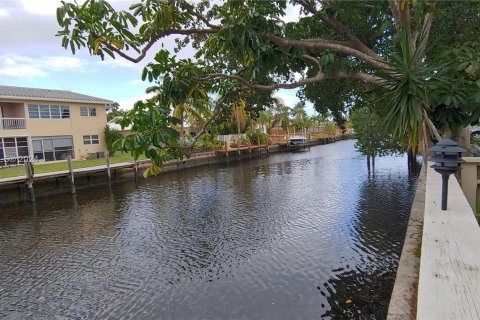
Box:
[0,141,415,319]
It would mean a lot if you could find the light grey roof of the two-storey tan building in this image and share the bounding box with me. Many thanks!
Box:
[0,85,113,104]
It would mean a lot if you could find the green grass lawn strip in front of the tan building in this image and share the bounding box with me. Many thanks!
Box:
[0,152,145,179]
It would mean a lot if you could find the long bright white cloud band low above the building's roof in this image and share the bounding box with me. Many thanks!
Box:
[0,55,87,78]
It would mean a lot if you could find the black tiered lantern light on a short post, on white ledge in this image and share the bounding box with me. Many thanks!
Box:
[429,139,465,210]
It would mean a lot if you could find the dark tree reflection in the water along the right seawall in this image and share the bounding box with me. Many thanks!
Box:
[317,169,416,319]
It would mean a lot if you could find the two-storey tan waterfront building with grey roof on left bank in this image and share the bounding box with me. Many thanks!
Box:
[0,85,112,166]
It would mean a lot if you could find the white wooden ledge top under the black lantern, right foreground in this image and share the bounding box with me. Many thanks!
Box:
[417,165,480,319]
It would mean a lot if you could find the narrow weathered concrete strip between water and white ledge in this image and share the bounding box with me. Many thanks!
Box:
[387,167,426,320]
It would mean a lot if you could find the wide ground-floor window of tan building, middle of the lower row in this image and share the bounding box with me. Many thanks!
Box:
[32,136,75,161]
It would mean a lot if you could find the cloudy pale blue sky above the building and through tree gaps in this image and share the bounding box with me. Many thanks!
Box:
[0,0,313,114]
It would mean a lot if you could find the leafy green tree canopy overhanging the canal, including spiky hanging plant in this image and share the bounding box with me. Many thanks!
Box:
[57,0,480,170]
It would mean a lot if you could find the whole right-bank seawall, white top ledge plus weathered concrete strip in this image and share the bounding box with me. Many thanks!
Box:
[387,163,480,320]
